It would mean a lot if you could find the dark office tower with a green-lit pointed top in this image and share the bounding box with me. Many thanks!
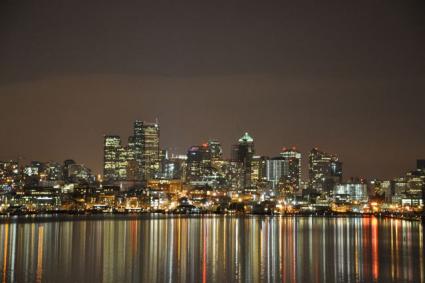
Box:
[232,133,255,190]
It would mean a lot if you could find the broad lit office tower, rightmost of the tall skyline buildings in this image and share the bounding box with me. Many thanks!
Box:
[309,148,342,193]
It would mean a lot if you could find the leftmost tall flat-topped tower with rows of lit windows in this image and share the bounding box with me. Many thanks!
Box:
[102,135,121,181]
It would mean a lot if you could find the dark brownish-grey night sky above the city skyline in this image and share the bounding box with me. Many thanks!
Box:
[0,0,425,181]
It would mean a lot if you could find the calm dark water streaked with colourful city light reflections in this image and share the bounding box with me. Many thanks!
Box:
[0,216,425,282]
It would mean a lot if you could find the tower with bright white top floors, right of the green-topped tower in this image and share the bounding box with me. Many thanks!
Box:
[280,147,301,190]
